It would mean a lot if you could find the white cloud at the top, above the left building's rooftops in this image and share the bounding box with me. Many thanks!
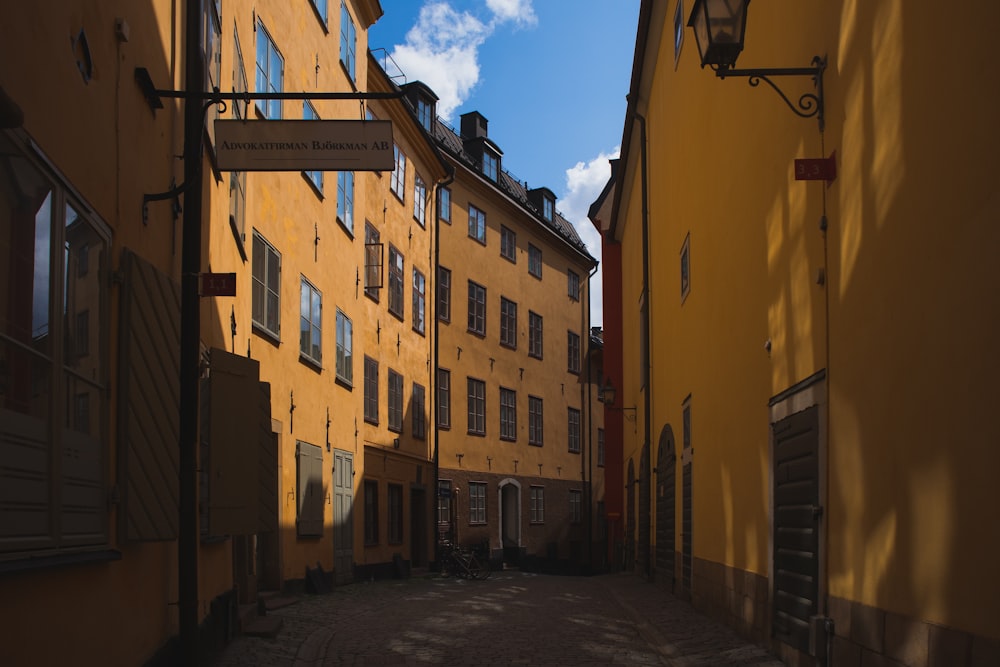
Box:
[391,0,538,121]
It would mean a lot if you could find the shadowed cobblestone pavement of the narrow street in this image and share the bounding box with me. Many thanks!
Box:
[208,571,782,667]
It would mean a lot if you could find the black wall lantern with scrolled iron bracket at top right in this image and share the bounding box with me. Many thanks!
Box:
[688,0,826,132]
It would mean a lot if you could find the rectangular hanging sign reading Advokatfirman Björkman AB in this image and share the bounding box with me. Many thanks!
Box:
[215,120,396,171]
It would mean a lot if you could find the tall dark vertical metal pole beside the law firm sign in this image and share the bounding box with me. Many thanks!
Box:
[177,0,204,665]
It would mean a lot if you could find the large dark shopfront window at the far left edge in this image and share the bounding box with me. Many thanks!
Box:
[0,131,111,557]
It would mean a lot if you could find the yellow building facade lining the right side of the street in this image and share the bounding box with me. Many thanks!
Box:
[603,0,1000,665]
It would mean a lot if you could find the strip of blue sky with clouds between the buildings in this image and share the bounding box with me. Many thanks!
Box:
[368,0,640,326]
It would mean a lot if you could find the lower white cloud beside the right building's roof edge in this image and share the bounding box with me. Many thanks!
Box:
[559,148,620,326]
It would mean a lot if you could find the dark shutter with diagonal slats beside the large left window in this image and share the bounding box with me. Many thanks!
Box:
[118,250,181,541]
